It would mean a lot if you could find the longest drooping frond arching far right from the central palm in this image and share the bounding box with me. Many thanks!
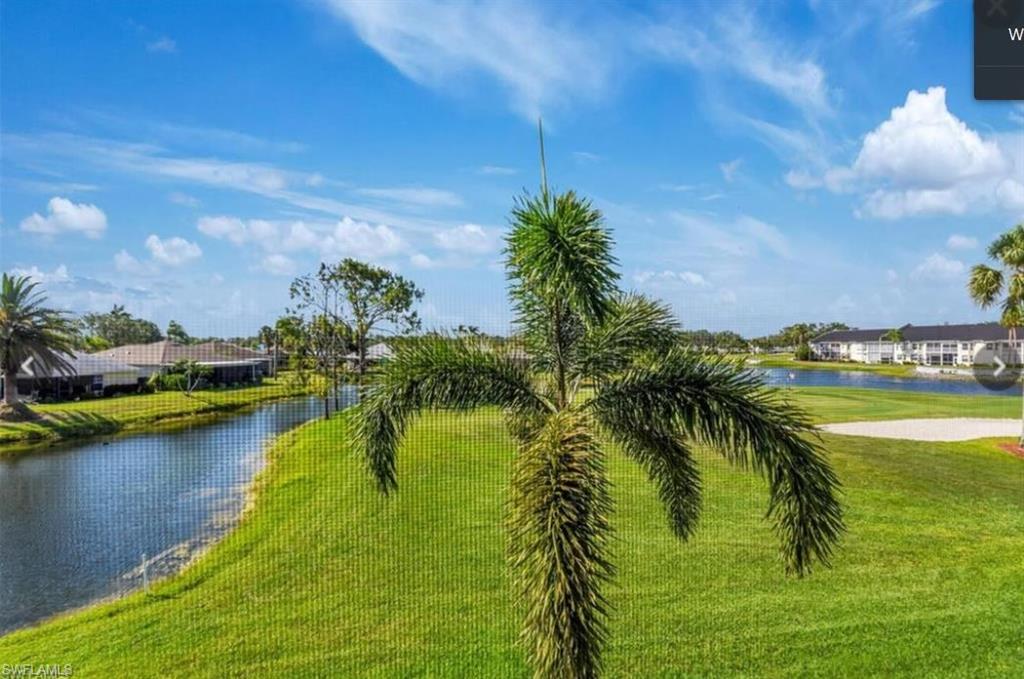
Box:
[591,349,844,575]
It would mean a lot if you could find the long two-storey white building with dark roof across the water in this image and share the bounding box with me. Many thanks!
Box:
[810,323,1024,366]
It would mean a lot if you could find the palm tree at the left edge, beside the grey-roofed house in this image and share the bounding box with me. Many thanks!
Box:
[0,273,75,418]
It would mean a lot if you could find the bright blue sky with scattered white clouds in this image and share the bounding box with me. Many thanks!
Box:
[0,0,1024,335]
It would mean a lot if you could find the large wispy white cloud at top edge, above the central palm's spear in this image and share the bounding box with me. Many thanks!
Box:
[324,0,611,120]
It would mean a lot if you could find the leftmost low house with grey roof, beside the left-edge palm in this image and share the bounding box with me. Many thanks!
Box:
[0,352,140,398]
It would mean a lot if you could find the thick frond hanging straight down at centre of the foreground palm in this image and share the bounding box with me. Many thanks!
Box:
[508,411,614,678]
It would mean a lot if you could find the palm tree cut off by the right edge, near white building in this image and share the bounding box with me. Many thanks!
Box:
[967,224,1024,445]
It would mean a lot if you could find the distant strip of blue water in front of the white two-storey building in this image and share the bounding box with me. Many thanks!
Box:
[752,368,1021,397]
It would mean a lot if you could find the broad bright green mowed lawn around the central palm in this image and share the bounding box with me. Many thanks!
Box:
[0,392,1024,677]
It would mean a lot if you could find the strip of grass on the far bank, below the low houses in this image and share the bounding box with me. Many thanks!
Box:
[0,378,311,455]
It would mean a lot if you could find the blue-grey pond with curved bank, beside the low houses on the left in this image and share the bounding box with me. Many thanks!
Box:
[0,390,354,634]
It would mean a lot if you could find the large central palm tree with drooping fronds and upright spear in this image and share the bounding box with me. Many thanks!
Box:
[354,130,843,677]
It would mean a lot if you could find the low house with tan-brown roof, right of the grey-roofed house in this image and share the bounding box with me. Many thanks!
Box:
[93,340,271,384]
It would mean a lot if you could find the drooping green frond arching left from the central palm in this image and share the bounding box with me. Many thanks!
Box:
[354,338,552,494]
